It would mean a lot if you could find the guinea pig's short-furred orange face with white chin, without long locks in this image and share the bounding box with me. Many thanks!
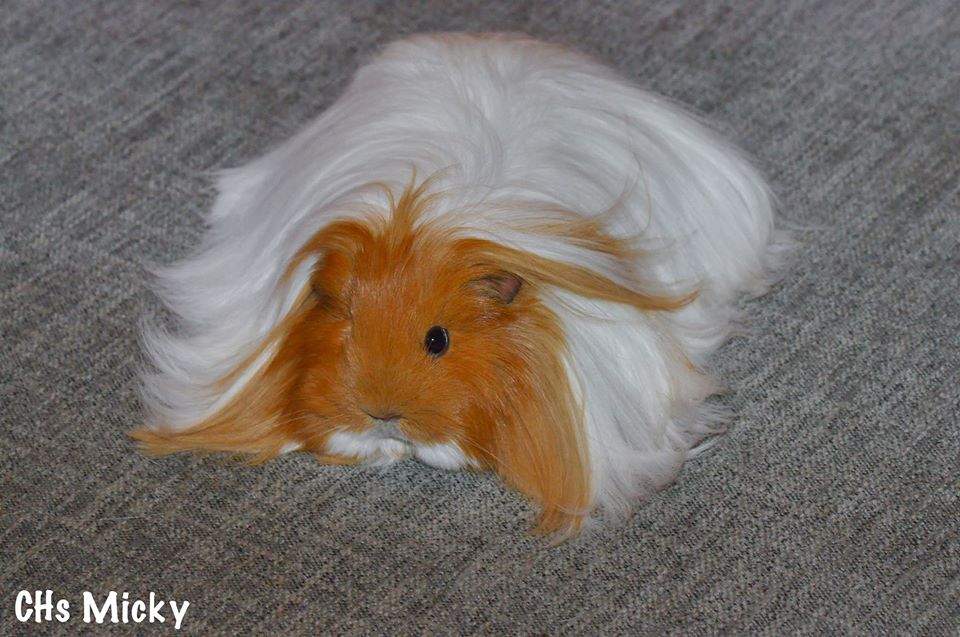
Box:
[289,214,540,469]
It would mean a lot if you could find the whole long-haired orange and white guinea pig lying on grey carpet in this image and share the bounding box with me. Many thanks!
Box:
[133,34,788,533]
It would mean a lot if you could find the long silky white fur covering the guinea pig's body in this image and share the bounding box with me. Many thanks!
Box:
[143,34,788,513]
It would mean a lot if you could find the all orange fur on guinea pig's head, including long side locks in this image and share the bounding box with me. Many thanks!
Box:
[132,182,689,532]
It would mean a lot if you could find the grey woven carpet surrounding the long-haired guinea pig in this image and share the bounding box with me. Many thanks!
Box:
[0,0,960,634]
